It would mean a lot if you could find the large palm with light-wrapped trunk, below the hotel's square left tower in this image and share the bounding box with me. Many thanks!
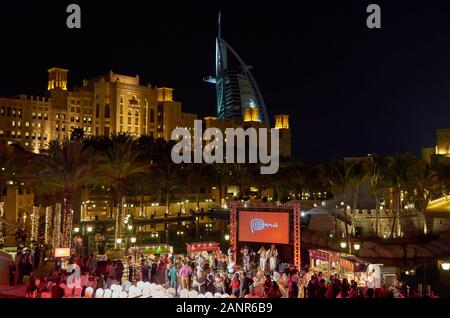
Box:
[39,139,95,247]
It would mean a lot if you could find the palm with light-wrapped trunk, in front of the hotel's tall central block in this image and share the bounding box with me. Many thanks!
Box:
[99,134,149,247]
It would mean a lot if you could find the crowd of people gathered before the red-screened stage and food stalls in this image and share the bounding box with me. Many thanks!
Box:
[10,245,437,298]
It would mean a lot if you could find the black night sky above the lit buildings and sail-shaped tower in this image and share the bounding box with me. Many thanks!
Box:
[0,0,450,162]
